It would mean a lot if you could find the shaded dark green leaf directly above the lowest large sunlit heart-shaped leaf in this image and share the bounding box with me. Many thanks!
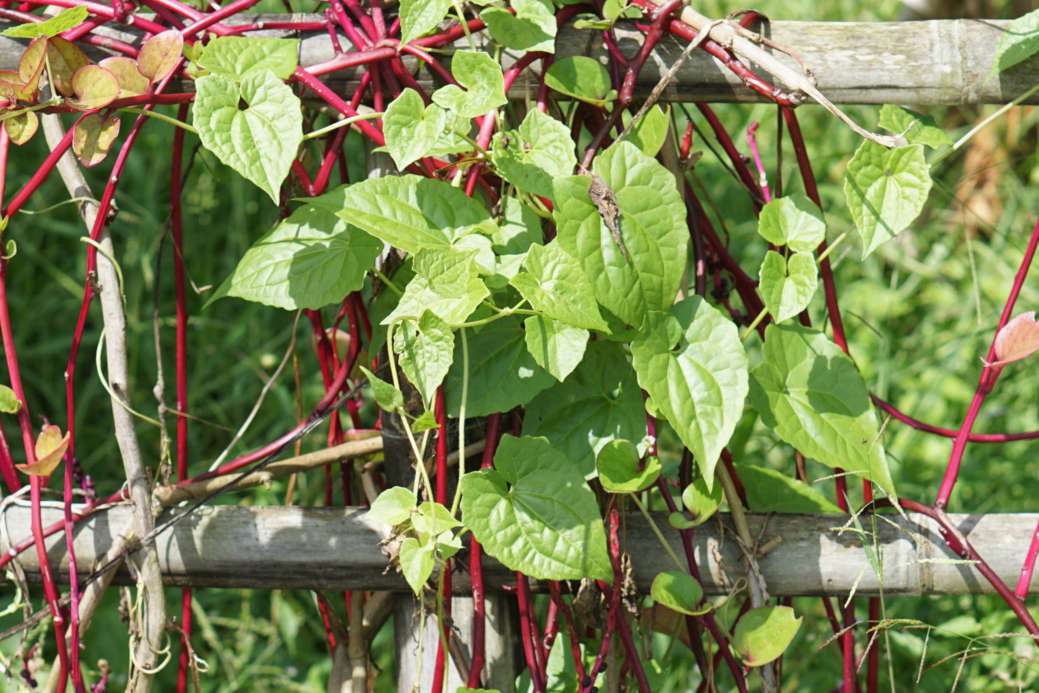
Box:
[523,341,646,477]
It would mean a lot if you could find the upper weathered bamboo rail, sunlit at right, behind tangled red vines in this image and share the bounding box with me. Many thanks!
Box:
[0,15,1039,106]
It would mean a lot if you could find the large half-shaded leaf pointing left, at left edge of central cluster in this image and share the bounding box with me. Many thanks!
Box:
[207,205,382,311]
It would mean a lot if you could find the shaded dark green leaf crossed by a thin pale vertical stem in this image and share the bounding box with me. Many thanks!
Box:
[447,317,555,417]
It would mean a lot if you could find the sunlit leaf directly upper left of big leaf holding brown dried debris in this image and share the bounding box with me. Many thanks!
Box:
[491,107,578,199]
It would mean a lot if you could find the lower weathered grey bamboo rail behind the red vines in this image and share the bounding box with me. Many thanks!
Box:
[0,504,1039,596]
